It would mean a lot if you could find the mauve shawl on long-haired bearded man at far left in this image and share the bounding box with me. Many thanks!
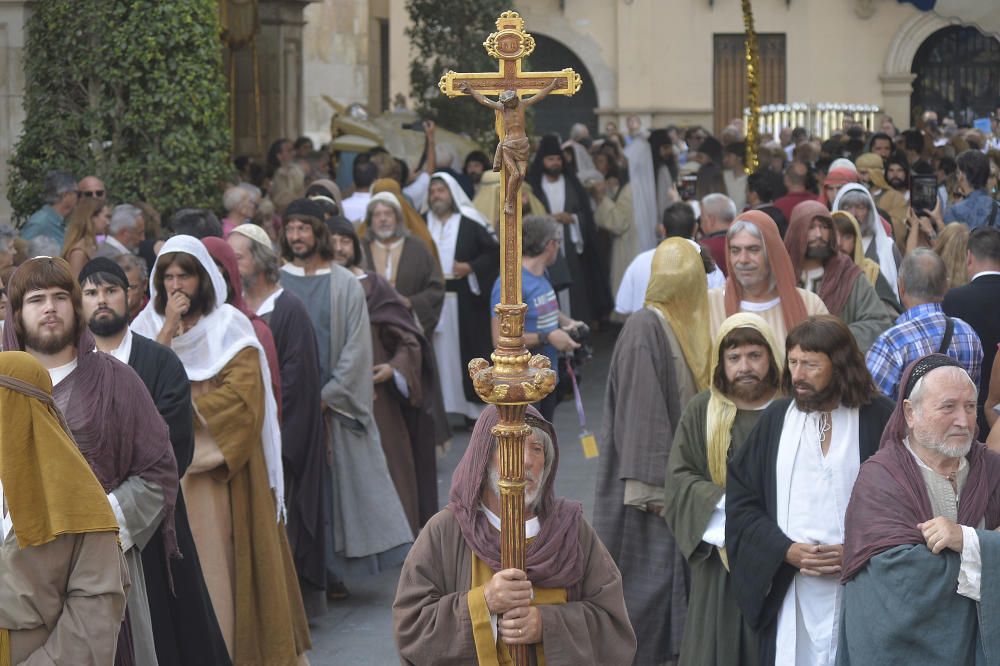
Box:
[3,326,181,556]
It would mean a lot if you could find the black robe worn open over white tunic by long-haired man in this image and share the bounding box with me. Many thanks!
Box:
[726,394,896,666]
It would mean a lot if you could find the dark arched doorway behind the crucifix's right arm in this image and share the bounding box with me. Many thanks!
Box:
[525,33,597,139]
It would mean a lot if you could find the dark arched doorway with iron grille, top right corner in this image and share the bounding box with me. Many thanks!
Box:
[910,26,1000,124]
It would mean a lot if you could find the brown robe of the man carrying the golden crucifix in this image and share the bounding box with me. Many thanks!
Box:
[392,509,635,666]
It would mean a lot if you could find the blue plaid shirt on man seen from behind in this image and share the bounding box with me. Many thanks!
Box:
[865,303,983,400]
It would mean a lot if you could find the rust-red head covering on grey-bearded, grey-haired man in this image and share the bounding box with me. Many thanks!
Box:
[726,210,809,331]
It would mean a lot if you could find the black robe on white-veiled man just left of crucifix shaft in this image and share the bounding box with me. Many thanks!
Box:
[444,216,500,403]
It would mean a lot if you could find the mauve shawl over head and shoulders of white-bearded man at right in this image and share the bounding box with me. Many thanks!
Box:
[841,354,1000,583]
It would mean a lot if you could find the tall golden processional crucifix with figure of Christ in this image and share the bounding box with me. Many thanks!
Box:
[438,11,581,666]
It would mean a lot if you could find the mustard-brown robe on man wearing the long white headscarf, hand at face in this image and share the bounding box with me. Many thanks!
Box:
[182,347,310,666]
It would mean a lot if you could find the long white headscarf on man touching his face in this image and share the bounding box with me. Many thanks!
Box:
[131,236,285,520]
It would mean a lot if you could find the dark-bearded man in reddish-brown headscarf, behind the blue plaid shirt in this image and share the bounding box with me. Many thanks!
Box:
[785,201,892,352]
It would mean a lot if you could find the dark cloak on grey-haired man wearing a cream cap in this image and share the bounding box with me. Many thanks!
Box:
[262,289,326,617]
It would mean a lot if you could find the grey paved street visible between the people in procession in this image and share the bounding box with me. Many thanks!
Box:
[309,324,614,666]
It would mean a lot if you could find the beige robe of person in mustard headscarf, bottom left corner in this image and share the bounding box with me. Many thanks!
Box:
[0,530,129,666]
